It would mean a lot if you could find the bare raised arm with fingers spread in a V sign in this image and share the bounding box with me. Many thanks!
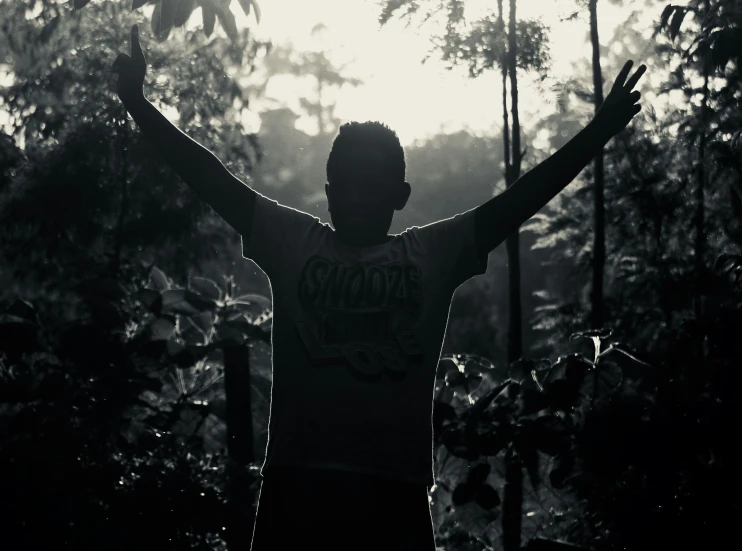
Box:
[475,61,647,254]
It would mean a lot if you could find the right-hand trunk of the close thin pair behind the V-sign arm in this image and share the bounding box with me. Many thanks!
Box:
[506,0,523,363]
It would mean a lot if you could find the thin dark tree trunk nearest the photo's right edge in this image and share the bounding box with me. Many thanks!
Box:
[693,0,711,321]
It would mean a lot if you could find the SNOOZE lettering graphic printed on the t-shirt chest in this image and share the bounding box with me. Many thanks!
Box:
[295,255,423,381]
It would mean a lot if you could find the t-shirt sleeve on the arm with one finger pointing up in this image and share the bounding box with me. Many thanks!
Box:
[242,193,320,278]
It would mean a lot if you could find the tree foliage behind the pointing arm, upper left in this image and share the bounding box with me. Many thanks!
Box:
[0,2,264,296]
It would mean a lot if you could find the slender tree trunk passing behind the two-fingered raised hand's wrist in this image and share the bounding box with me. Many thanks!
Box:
[590,0,605,329]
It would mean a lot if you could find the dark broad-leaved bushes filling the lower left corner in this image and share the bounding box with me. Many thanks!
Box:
[0,268,270,550]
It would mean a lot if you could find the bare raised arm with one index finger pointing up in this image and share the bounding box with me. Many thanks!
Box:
[112,25,256,237]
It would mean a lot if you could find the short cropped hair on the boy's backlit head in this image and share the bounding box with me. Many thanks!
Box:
[327,121,406,182]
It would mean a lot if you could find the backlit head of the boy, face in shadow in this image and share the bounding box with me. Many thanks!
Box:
[325,122,411,241]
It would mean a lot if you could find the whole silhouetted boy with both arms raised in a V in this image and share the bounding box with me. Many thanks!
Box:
[113,22,646,551]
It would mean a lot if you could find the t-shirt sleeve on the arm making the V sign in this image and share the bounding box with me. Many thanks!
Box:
[415,209,488,290]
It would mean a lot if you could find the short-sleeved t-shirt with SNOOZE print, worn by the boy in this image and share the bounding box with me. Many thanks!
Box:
[242,194,487,487]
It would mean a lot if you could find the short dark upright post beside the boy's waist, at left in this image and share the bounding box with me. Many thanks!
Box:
[224,345,255,551]
